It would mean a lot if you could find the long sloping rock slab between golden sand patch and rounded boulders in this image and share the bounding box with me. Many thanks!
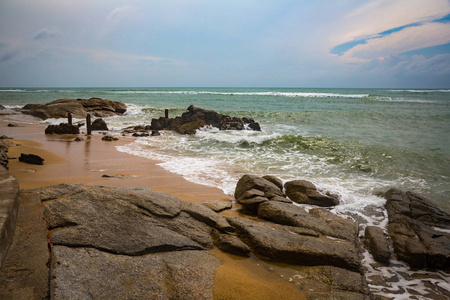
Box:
[227,217,361,272]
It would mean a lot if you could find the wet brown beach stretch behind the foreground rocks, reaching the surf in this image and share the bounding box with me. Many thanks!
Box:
[0,120,233,202]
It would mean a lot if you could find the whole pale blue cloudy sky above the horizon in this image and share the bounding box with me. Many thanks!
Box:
[0,0,450,88]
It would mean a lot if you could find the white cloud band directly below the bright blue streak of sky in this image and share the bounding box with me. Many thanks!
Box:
[343,23,450,59]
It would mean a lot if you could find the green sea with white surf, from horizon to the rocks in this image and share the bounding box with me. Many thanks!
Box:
[0,88,450,298]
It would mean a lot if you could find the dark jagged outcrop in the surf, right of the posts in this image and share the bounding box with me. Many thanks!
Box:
[151,105,261,134]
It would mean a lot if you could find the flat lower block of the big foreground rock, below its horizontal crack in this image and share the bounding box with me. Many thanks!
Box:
[50,246,221,299]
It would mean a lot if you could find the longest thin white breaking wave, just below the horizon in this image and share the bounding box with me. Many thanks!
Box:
[108,90,369,98]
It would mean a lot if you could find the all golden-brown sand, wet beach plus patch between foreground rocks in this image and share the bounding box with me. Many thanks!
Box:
[0,119,306,299]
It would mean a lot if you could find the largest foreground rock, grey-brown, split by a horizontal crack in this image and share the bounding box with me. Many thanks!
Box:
[33,184,234,299]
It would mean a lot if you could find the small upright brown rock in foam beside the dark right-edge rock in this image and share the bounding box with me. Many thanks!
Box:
[364,226,391,264]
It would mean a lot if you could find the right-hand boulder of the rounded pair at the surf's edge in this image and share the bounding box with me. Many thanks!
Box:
[284,180,339,207]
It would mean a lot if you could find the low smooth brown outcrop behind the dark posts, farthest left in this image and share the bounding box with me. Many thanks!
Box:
[22,98,127,120]
